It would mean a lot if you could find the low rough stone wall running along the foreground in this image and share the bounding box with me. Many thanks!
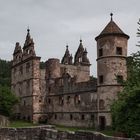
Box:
[0,126,134,140]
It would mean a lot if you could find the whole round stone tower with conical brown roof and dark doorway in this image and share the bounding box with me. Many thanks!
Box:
[95,14,129,129]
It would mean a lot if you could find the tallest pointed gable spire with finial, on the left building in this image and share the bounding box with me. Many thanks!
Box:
[23,28,34,49]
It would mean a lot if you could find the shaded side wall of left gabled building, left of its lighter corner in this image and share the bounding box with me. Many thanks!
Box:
[11,60,33,120]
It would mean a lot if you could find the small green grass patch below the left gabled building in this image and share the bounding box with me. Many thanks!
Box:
[9,120,37,128]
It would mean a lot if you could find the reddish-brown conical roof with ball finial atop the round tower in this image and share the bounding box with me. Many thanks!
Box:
[95,13,129,40]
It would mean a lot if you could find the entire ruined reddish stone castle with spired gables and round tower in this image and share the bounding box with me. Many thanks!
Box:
[12,17,129,129]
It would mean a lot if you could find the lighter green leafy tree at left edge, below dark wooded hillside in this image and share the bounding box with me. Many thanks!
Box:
[0,85,18,116]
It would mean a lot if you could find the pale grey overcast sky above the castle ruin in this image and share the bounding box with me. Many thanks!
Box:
[0,0,140,76]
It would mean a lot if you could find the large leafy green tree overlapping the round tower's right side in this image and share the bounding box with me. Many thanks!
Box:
[111,20,140,137]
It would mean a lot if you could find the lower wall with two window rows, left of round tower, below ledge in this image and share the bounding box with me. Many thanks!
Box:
[46,92,97,127]
